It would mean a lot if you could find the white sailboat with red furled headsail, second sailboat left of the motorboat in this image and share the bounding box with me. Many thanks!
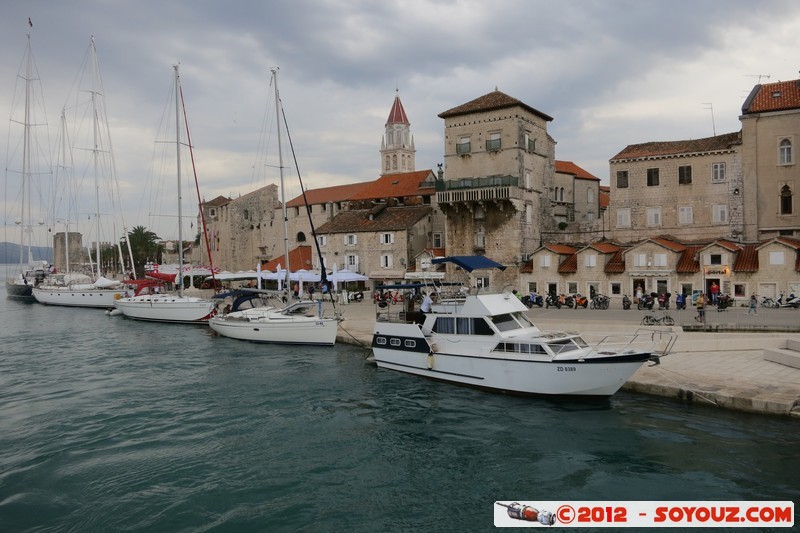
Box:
[115,65,216,324]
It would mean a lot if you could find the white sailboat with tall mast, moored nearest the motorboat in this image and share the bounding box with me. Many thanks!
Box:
[208,69,341,346]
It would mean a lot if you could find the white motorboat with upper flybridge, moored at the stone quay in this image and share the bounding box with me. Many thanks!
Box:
[372,258,675,396]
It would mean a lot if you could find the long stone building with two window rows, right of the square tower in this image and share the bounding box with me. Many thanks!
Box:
[609,132,744,241]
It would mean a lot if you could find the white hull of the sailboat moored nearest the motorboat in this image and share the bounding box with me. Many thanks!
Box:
[208,317,339,346]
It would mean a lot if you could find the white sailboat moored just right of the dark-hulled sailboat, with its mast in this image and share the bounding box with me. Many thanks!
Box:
[33,38,133,309]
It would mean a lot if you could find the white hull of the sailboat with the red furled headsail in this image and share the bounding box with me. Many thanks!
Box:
[114,295,216,324]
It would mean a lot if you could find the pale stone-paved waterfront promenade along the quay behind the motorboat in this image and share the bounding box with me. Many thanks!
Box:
[326,301,800,418]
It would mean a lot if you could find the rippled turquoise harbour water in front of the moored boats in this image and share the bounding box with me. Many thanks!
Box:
[0,294,800,532]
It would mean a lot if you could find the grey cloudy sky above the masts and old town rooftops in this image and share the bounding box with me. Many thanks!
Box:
[0,0,800,243]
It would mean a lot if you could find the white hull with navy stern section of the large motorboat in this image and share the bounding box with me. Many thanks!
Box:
[372,324,650,396]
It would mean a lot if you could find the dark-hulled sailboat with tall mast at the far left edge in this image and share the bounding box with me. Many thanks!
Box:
[5,34,50,300]
